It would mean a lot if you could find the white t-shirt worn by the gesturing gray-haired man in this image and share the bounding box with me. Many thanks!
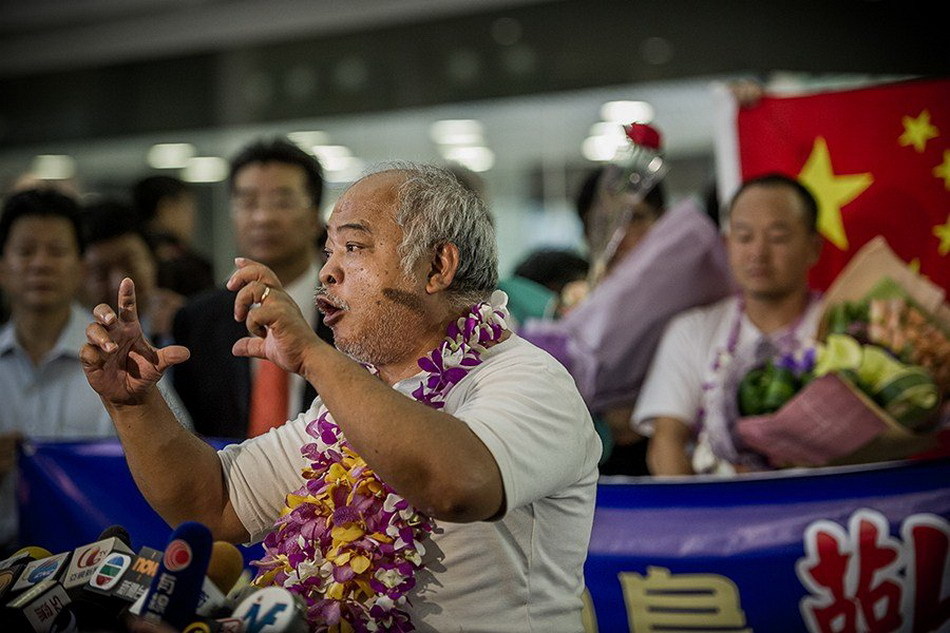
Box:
[219,335,601,633]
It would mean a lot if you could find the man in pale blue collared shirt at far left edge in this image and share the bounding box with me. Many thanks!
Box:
[0,189,115,553]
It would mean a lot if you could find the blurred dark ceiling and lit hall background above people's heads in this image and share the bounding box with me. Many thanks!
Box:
[0,0,950,277]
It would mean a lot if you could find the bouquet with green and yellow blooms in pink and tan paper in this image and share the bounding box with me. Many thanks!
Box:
[735,238,950,467]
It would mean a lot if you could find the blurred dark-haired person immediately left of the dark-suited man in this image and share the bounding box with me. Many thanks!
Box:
[132,176,215,297]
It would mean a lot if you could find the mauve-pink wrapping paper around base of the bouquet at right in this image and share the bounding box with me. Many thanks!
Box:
[736,374,934,468]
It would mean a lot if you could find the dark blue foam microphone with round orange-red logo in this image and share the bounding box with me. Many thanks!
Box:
[140,521,212,629]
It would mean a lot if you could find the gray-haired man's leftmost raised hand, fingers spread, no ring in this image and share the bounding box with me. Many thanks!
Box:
[79,277,190,405]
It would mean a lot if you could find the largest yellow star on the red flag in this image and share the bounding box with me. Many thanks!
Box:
[798,136,874,250]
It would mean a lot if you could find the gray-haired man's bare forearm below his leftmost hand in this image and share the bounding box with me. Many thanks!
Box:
[105,388,248,542]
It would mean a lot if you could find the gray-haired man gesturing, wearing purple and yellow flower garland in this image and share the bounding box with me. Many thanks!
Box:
[82,164,601,633]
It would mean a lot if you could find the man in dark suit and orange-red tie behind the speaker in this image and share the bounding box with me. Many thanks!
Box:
[172,138,332,439]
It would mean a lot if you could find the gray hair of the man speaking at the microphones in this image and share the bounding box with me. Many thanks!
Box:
[364,161,498,308]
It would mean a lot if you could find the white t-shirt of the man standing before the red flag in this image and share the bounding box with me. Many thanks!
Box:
[632,296,821,468]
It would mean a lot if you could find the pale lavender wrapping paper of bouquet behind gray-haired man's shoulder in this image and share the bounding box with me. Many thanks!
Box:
[519,200,733,411]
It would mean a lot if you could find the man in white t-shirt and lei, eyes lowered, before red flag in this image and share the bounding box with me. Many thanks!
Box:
[633,174,821,475]
